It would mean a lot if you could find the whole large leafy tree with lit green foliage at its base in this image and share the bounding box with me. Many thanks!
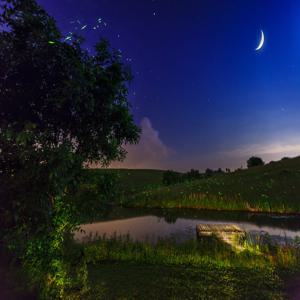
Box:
[0,0,139,299]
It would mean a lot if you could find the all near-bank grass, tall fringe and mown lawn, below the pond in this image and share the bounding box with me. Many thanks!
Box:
[84,238,299,299]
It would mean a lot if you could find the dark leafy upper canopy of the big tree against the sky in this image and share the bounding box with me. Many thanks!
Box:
[0,0,138,162]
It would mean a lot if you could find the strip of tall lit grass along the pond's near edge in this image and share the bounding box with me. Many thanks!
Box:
[84,236,300,269]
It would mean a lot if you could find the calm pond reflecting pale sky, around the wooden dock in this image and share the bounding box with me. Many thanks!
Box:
[74,208,300,242]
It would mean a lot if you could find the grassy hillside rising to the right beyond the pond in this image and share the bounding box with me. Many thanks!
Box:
[126,157,300,213]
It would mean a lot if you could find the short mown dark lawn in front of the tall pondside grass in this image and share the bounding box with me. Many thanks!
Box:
[90,263,283,300]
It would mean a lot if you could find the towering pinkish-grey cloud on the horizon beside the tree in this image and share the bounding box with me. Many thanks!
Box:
[111,118,174,169]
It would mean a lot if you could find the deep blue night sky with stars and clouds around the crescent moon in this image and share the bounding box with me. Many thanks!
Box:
[38,0,300,170]
